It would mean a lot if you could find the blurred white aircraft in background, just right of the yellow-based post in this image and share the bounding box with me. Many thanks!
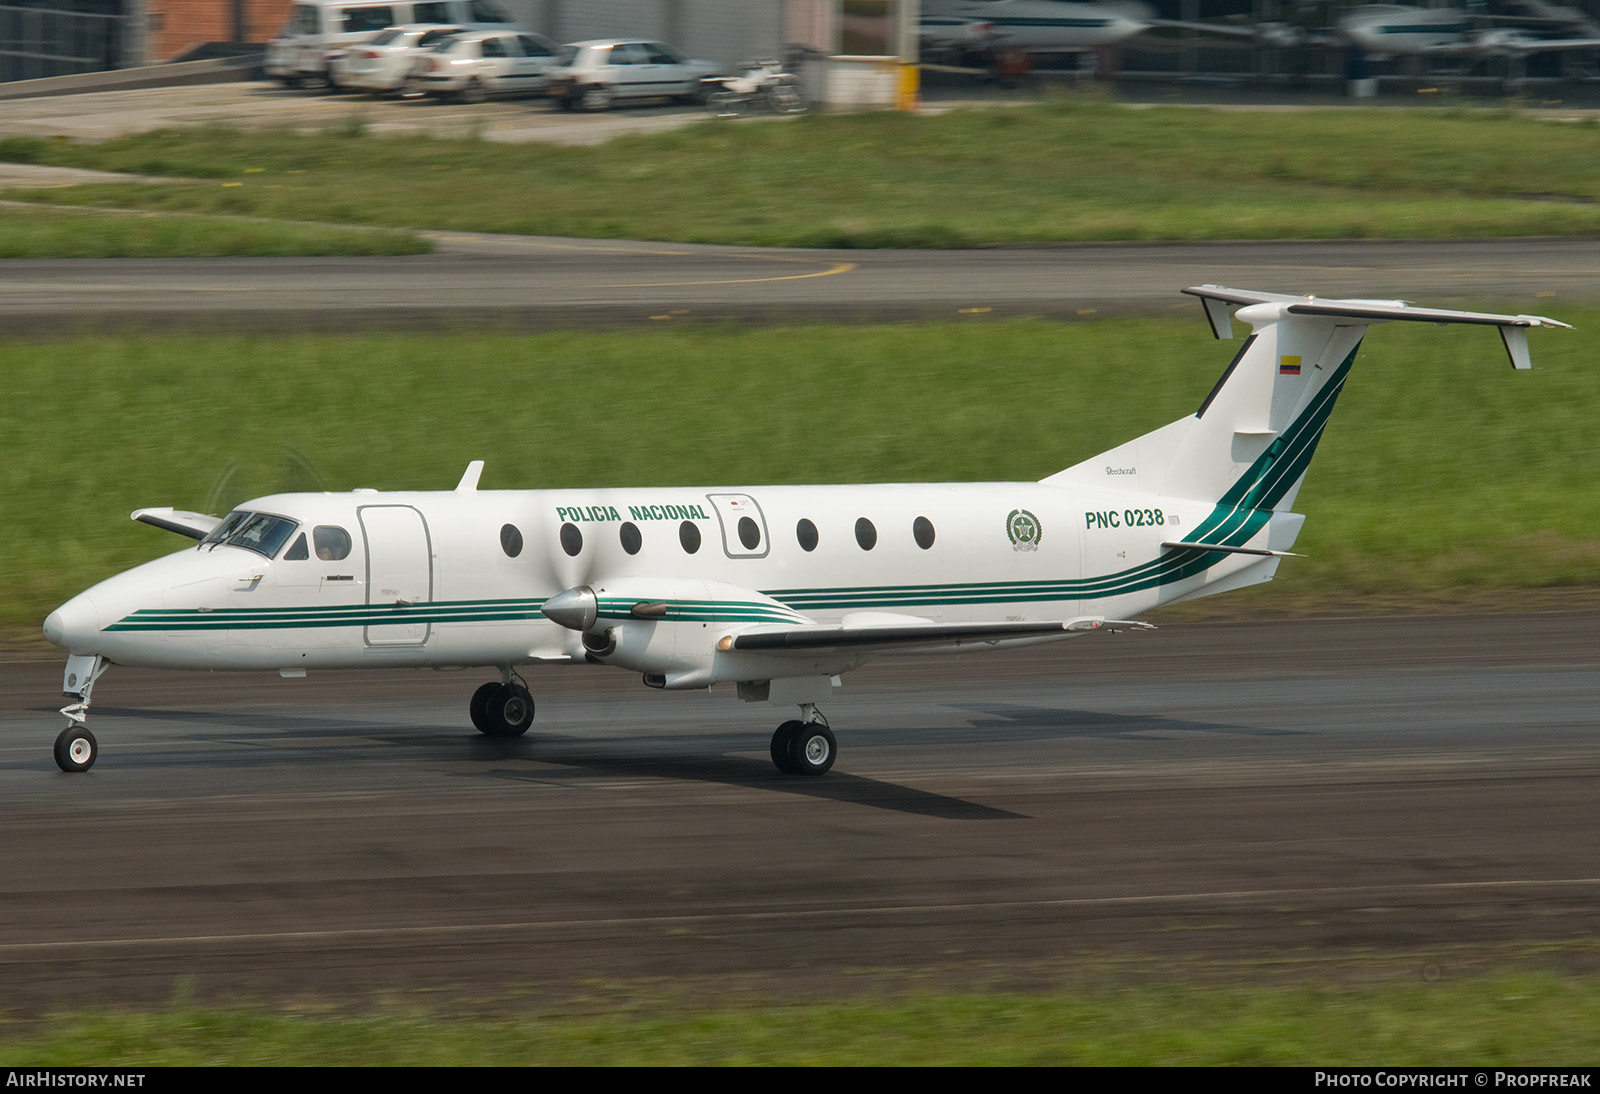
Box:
[918,0,1152,53]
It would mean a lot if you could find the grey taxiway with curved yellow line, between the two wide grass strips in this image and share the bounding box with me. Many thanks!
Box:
[0,234,1600,336]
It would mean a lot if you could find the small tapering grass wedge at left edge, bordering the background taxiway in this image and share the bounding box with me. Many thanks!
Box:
[0,203,434,259]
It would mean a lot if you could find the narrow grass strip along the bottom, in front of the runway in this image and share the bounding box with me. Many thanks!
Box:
[0,974,1600,1068]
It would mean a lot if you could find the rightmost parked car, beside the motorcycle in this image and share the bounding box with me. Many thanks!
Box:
[549,38,728,110]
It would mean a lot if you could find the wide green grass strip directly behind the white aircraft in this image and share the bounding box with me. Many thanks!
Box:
[0,316,1600,641]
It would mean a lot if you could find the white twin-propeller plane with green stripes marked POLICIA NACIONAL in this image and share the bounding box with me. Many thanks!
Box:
[45,285,1566,774]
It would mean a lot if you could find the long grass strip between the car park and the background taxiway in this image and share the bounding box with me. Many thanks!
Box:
[0,101,1600,248]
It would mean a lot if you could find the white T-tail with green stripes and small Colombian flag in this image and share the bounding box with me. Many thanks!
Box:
[1043,285,1568,595]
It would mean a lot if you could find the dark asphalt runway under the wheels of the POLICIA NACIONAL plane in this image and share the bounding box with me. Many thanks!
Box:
[0,613,1600,1012]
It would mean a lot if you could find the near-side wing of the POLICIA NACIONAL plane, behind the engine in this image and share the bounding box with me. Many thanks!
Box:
[718,616,1154,653]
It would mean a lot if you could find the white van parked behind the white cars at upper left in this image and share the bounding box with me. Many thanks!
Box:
[266,0,517,88]
